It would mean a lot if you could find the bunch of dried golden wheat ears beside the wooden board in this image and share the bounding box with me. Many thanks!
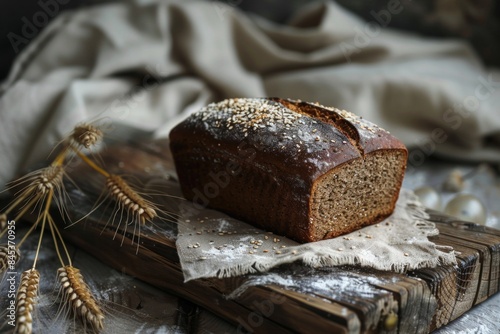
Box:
[0,119,168,333]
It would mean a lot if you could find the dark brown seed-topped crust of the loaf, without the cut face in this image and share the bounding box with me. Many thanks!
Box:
[170,98,406,242]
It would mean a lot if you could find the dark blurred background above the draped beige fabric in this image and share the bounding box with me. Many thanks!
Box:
[0,0,500,80]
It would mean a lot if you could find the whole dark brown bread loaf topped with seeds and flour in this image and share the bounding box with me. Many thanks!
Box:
[170,98,407,242]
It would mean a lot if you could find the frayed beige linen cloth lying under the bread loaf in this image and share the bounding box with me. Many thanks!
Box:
[176,189,456,281]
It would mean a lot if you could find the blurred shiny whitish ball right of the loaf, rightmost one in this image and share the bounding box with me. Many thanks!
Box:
[444,194,486,225]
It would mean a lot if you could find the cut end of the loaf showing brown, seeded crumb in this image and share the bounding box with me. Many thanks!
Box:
[309,150,406,241]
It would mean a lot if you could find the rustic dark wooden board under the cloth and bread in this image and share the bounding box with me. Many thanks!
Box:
[54,141,500,333]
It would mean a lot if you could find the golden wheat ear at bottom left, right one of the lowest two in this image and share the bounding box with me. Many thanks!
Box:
[57,266,104,331]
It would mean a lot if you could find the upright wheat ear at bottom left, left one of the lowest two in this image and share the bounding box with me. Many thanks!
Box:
[16,269,40,334]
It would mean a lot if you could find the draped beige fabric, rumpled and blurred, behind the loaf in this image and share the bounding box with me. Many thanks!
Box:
[0,1,500,185]
